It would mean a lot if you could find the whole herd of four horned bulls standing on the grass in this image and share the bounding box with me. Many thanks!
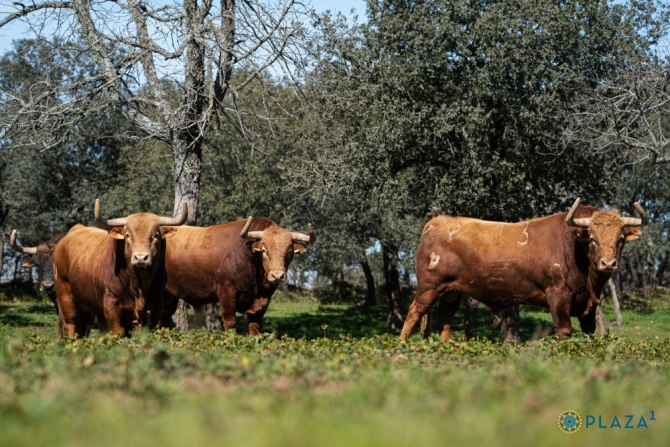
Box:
[10,198,648,342]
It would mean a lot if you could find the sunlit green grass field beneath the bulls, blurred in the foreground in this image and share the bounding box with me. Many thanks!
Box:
[0,290,670,446]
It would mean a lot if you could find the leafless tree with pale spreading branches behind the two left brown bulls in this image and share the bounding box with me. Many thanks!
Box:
[0,0,309,328]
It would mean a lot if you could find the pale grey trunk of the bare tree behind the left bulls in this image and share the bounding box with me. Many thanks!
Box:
[172,135,203,331]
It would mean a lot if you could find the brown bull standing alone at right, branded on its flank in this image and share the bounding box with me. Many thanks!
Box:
[400,199,647,342]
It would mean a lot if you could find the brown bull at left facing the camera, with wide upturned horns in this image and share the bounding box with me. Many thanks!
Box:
[54,200,188,337]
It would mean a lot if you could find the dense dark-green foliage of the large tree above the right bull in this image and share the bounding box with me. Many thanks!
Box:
[304,0,652,221]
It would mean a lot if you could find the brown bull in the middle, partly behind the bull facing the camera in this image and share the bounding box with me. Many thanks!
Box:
[163,217,315,335]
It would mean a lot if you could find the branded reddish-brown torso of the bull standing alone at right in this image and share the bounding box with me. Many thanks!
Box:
[416,214,566,302]
